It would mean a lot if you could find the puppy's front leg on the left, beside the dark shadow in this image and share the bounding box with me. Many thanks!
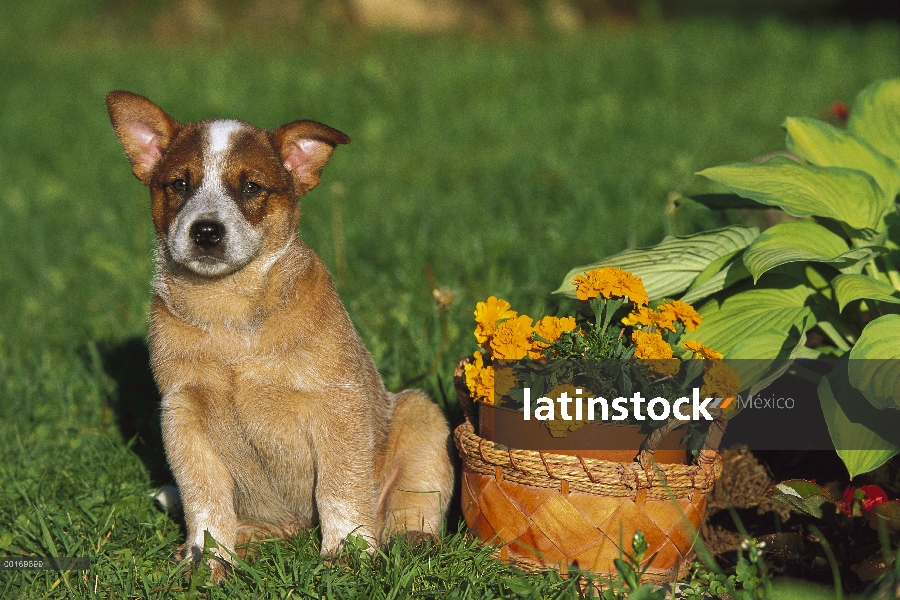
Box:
[162,393,237,579]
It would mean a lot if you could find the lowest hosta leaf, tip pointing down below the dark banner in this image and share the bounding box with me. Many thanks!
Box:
[819,358,900,478]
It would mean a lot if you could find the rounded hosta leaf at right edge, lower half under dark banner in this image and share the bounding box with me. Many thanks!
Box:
[848,315,900,408]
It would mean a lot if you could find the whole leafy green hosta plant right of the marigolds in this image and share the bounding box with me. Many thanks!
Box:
[557,79,900,477]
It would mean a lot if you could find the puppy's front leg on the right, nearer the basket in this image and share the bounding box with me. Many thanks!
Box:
[314,404,378,556]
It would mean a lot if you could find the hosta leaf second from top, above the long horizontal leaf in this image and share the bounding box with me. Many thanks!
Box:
[784,115,900,199]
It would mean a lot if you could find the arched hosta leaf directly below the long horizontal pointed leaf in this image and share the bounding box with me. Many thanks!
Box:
[744,221,882,282]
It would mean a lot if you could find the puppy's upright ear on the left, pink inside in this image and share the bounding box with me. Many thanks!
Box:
[106,91,181,185]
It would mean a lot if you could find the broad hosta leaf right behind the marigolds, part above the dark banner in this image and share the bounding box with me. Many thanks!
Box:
[686,274,816,359]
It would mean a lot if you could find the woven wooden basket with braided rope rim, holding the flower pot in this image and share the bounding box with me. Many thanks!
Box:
[454,421,722,581]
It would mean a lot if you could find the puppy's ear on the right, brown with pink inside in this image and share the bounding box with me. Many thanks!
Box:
[272,121,350,195]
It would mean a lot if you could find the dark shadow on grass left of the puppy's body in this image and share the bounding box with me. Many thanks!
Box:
[100,337,175,486]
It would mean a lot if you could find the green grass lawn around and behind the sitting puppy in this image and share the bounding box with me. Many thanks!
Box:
[0,7,900,598]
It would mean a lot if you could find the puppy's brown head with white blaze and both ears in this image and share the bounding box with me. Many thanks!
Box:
[106,91,350,277]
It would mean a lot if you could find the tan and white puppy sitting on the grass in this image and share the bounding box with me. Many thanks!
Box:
[106,91,453,577]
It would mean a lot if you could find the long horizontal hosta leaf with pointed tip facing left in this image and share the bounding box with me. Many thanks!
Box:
[698,156,893,231]
